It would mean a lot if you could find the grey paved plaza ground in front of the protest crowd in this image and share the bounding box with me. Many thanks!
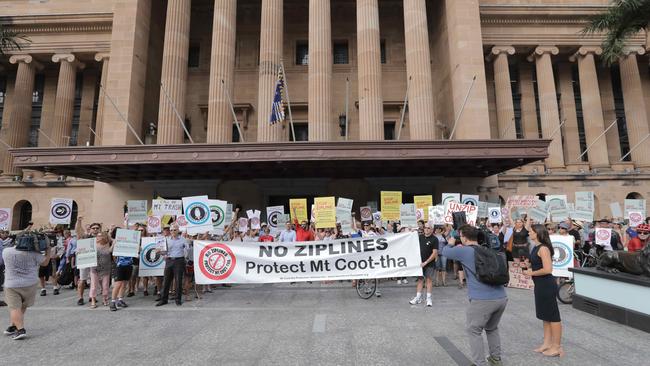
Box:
[0,281,650,366]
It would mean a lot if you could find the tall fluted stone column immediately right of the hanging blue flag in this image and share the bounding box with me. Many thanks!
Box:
[309,0,334,141]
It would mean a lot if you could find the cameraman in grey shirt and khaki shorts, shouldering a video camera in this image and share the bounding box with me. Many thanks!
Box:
[2,240,53,340]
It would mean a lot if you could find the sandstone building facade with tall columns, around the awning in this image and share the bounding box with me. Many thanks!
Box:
[0,0,650,229]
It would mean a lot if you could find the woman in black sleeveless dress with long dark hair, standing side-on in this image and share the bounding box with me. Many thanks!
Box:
[524,219,564,357]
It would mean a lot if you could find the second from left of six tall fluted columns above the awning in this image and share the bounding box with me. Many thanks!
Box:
[207,0,237,144]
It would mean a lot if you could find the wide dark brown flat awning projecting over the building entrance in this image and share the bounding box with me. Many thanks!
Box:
[10,140,550,183]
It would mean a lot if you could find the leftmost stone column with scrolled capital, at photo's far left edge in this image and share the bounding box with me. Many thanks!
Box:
[2,55,43,175]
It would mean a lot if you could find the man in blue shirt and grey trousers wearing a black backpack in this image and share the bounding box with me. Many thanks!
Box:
[442,225,508,366]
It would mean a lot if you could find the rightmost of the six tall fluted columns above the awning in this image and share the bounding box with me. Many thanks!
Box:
[404,0,436,140]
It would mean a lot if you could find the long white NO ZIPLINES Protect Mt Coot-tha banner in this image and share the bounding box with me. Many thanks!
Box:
[194,232,422,285]
